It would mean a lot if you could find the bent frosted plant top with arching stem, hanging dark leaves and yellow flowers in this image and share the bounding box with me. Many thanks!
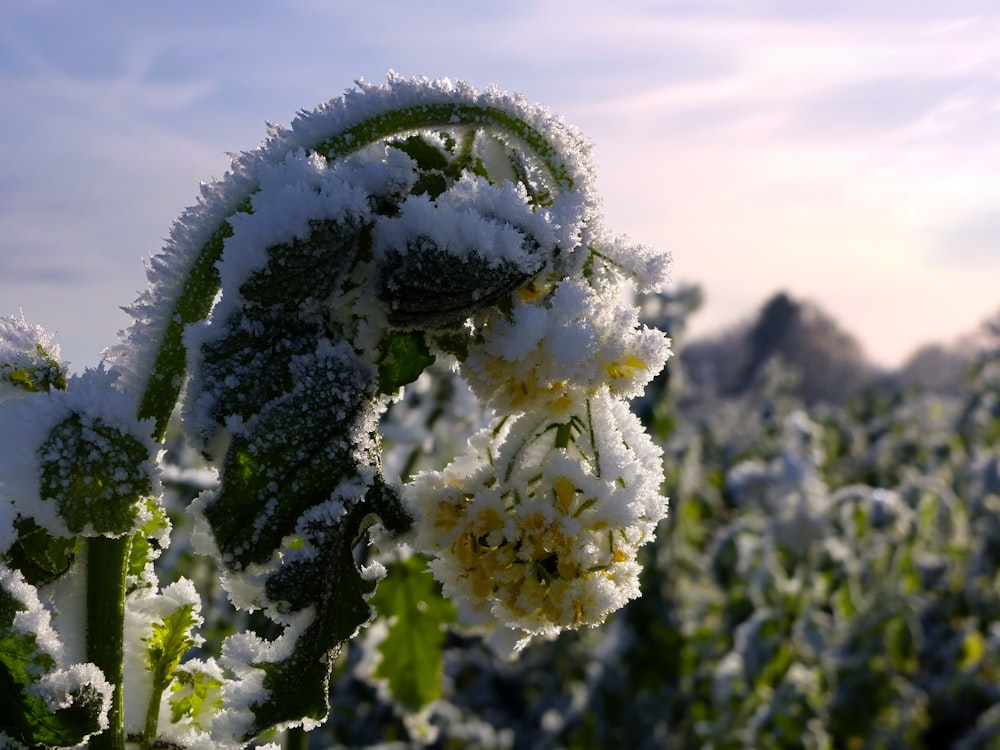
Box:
[94,75,669,744]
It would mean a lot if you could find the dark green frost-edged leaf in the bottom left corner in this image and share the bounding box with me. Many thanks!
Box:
[0,587,104,747]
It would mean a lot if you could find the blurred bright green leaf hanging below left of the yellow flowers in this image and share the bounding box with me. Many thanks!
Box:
[371,556,456,711]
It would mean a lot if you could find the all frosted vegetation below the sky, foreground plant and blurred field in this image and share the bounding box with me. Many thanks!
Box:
[7,72,1000,750]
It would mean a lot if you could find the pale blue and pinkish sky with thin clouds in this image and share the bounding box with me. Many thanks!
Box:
[0,0,1000,372]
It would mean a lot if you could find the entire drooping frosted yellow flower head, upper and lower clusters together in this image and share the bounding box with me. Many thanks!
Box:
[406,175,670,645]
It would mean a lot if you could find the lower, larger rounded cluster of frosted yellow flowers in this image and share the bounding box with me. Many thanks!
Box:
[410,389,666,648]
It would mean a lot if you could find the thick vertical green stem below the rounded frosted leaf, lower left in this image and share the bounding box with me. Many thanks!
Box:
[87,534,132,750]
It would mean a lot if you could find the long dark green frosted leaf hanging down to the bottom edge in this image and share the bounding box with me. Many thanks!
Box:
[197,339,411,739]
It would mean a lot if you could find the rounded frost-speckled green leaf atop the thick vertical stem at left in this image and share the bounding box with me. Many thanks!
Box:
[38,414,153,534]
